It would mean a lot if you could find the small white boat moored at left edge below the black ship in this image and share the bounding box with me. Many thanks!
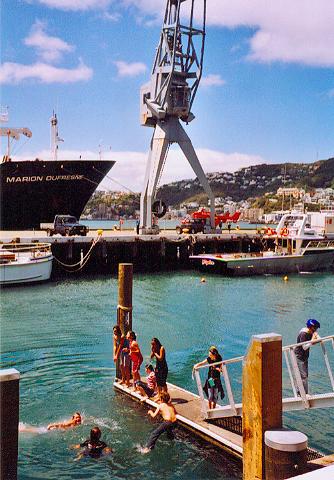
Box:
[0,242,53,286]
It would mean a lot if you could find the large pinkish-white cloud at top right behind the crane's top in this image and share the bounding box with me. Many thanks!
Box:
[125,0,334,67]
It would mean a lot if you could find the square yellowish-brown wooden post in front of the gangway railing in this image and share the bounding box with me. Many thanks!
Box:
[242,333,282,480]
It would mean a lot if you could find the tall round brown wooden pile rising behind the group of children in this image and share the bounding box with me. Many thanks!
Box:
[116,263,133,378]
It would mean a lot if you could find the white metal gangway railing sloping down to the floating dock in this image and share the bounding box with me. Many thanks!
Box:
[194,335,334,420]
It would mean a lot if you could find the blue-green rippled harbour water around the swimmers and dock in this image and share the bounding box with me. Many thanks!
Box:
[1,272,334,480]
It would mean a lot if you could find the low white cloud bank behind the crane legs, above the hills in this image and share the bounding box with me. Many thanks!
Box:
[20,147,268,192]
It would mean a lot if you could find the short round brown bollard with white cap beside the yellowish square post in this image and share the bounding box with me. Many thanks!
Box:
[265,429,307,480]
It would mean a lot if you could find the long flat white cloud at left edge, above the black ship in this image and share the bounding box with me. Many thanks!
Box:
[0,62,93,84]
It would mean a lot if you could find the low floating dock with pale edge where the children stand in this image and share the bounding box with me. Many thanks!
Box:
[114,382,242,460]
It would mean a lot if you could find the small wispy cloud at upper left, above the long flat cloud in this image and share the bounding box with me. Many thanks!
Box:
[24,20,74,62]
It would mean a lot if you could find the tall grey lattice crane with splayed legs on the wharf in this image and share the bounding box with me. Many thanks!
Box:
[140,0,215,234]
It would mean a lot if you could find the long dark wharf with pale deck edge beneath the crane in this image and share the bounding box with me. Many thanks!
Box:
[0,229,263,277]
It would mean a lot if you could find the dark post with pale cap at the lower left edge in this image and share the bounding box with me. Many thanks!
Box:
[0,368,20,480]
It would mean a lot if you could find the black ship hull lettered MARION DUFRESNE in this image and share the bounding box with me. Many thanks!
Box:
[0,160,115,230]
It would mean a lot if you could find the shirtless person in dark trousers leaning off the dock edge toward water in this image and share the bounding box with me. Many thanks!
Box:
[142,392,176,453]
